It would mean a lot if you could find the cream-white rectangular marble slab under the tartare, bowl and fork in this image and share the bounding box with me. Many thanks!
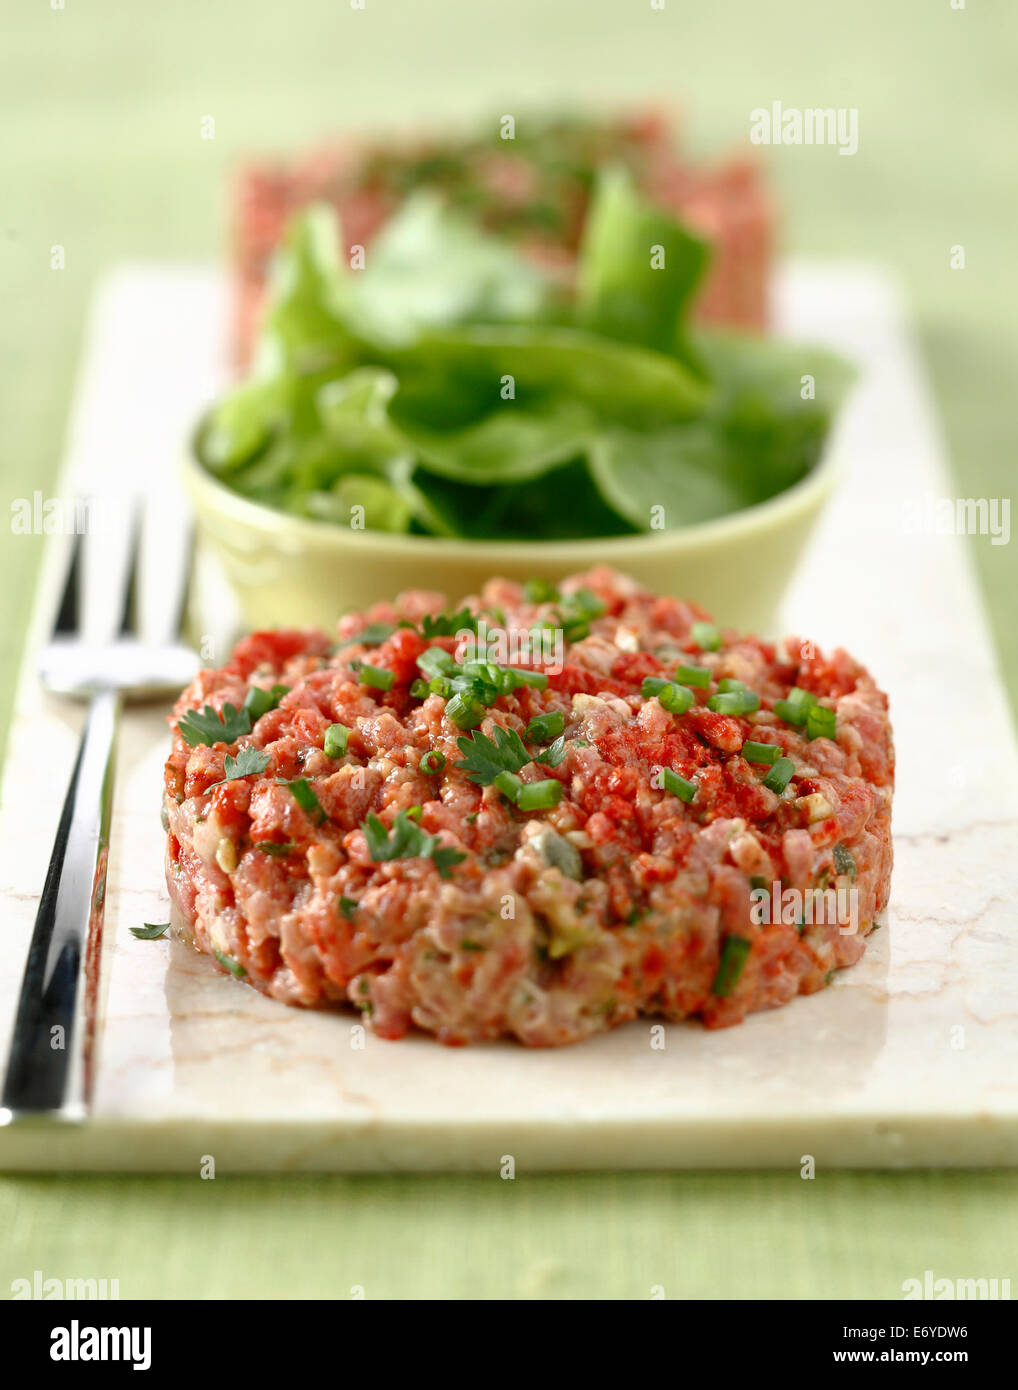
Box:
[0,255,1018,1172]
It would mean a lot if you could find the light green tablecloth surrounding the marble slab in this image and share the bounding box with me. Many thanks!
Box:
[0,0,1018,1298]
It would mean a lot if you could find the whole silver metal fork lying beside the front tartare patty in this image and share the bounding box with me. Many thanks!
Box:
[0,498,197,1123]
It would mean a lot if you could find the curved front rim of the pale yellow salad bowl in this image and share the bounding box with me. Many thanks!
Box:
[179,430,840,556]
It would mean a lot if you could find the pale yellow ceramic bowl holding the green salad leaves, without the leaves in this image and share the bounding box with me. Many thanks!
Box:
[184,450,834,631]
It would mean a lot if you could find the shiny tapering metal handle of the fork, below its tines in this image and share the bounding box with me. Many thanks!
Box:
[3,689,120,1120]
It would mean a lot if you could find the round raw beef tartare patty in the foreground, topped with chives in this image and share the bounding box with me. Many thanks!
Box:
[165,569,894,1047]
